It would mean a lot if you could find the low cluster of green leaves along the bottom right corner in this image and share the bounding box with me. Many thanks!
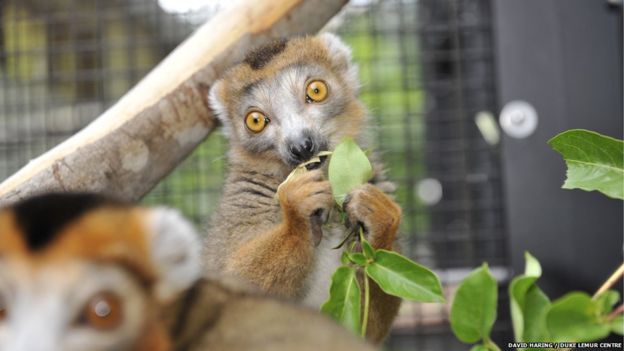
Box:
[451,252,624,351]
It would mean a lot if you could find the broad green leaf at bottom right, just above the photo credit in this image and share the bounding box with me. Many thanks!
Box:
[546,292,611,342]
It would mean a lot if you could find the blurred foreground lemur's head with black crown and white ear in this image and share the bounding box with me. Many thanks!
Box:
[0,194,200,351]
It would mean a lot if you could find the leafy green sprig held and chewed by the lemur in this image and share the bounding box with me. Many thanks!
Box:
[321,138,444,336]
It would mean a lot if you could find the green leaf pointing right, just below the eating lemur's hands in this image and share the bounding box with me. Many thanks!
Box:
[365,250,444,302]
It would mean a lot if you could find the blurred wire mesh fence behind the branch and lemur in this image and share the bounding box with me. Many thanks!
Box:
[0,0,509,350]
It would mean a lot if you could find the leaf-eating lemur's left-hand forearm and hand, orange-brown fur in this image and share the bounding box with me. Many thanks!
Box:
[225,171,333,297]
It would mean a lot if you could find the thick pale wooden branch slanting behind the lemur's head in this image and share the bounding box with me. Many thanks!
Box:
[0,0,347,205]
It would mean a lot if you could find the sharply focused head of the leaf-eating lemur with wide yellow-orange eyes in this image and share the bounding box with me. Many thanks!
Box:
[210,33,365,166]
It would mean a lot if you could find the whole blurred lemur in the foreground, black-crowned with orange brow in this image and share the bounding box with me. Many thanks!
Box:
[0,194,370,351]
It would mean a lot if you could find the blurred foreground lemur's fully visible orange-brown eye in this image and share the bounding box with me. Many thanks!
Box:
[81,293,122,330]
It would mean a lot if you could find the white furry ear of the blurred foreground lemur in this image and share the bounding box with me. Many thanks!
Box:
[148,207,201,302]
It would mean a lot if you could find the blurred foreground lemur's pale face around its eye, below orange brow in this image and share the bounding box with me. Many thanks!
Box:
[0,259,149,351]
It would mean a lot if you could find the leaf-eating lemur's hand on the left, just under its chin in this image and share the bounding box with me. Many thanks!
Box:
[277,170,334,244]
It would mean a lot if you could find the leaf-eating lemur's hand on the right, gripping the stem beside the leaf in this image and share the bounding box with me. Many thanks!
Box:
[343,184,401,250]
